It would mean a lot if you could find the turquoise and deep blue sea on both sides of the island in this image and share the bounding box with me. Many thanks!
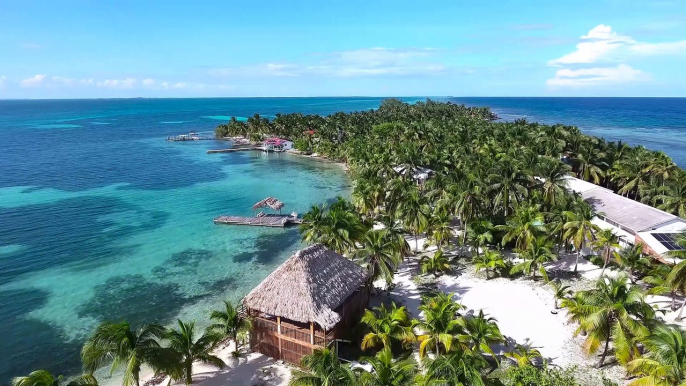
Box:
[0,98,686,384]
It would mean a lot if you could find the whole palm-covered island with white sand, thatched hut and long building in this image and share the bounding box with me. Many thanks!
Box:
[13,99,686,386]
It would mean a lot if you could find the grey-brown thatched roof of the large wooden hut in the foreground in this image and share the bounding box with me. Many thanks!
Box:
[244,244,367,330]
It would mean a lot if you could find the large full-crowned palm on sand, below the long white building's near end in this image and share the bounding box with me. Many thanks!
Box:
[569,275,655,367]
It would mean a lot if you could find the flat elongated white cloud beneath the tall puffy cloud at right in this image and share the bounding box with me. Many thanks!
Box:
[547,64,649,87]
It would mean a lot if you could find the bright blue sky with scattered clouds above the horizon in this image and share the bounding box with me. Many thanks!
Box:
[0,0,686,98]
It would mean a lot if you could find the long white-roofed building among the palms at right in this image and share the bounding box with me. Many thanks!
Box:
[567,177,686,259]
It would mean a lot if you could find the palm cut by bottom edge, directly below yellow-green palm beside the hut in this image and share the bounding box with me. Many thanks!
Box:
[358,348,416,386]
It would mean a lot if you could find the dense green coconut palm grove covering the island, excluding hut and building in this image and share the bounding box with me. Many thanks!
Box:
[12,99,686,386]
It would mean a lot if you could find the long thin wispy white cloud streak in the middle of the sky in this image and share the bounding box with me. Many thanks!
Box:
[210,47,448,77]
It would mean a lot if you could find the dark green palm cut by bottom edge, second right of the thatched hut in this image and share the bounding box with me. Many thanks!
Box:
[421,350,489,386]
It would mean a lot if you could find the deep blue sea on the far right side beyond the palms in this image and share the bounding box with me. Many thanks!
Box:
[448,98,686,167]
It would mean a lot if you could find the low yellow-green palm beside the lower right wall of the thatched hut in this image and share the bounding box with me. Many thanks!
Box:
[361,303,416,350]
